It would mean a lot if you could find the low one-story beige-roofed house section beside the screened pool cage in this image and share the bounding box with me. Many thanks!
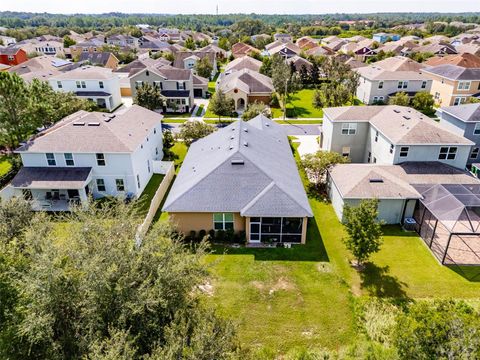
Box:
[328,162,480,225]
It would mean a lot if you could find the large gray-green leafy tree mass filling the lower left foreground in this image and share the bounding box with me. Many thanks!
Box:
[0,201,238,360]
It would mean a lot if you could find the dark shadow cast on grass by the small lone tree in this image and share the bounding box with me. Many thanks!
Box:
[360,263,408,300]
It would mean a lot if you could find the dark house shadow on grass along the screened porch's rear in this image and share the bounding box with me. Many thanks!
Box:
[212,219,329,262]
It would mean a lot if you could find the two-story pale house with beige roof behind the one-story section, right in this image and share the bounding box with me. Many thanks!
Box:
[321,105,474,169]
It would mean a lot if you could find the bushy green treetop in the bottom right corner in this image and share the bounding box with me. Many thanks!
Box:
[393,300,480,359]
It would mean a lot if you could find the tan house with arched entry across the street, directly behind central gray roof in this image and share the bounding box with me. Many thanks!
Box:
[217,69,275,111]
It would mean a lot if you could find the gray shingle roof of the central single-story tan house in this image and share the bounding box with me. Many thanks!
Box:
[163,115,312,217]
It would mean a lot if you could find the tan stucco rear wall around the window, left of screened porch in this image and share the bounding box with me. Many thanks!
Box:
[169,213,245,234]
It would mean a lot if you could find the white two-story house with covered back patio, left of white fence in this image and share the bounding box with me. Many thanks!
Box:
[7,105,163,211]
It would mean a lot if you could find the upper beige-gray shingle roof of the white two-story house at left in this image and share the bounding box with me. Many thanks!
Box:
[17,105,162,153]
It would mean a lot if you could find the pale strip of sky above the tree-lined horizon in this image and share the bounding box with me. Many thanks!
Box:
[0,0,480,14]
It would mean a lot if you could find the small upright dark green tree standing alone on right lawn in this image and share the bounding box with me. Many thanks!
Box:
[343,199,382,266]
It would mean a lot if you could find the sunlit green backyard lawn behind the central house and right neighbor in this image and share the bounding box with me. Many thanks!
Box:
[156,143,480,358]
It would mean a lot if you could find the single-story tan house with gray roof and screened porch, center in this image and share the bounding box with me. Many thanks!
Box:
[162,115,313,244]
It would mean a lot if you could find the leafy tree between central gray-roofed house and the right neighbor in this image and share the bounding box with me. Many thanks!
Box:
[301,151,349,191]
